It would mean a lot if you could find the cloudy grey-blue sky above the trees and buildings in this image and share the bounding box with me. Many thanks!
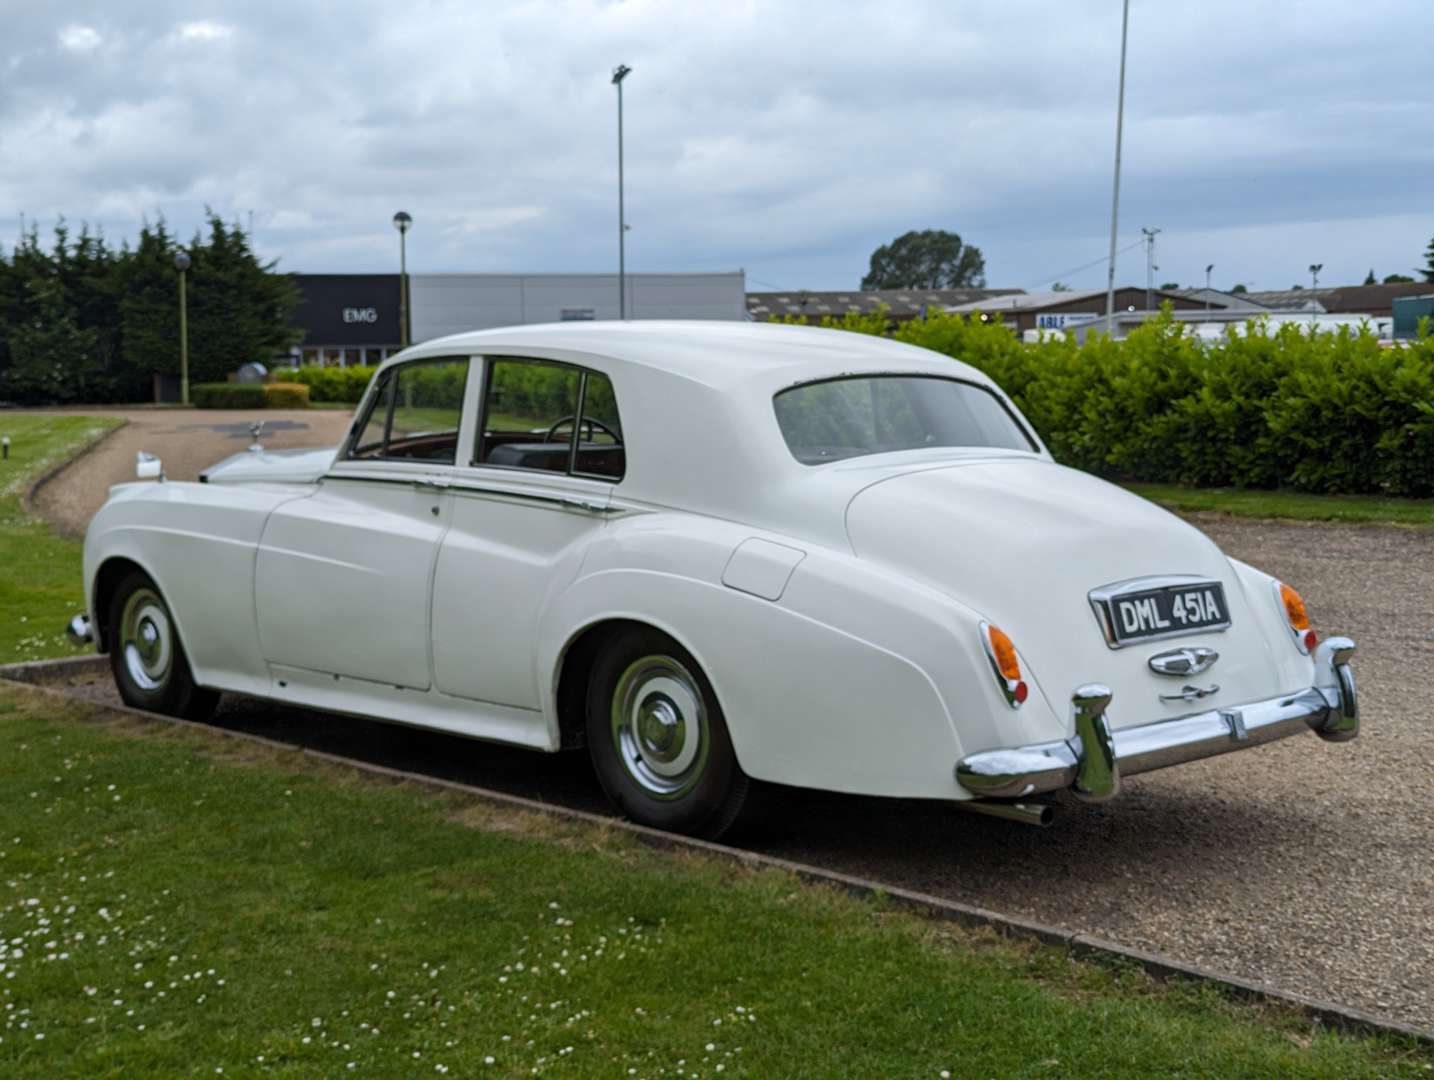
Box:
[0,0,1434,290]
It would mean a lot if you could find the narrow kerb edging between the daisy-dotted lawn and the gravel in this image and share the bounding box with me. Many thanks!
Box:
[0,655,1434,1046]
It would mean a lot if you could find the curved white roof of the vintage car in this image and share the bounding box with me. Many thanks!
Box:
[384,320,991,390]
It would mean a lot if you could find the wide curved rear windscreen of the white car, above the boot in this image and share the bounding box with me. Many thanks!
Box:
[774,376,1035,465]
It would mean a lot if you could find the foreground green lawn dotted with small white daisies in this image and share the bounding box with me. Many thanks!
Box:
[0,688,1434,1080]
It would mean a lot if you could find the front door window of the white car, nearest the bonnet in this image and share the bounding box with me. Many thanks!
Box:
[348,357,469,465]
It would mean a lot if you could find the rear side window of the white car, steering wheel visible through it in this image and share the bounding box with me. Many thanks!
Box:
[473,357,627,480]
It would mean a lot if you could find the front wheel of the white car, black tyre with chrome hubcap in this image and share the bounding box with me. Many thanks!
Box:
[109,571,219,720]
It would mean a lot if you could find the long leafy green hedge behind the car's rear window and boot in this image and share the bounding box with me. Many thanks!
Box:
[785,306,1434,496]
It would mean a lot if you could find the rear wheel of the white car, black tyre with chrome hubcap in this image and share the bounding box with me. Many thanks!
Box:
[588,628,751,839]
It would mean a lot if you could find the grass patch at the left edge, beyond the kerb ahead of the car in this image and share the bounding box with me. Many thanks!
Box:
[0,413,120,664]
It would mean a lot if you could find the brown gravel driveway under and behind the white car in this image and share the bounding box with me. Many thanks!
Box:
[33,519,1434,1028]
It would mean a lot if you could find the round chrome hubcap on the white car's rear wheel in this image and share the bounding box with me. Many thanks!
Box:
[612,655,708,799]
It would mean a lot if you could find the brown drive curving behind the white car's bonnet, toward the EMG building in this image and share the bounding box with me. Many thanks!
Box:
[26,407,353,536]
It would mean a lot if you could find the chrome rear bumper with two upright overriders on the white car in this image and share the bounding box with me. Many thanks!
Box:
[956,637,1359,802]
